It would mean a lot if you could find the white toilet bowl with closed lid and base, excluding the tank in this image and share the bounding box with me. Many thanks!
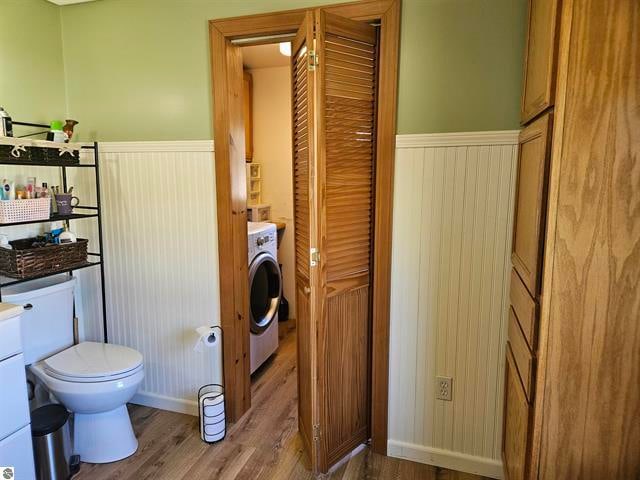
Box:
[29,342,144,463]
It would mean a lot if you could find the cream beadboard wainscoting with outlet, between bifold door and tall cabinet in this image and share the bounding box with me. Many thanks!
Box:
[388,131,518,478]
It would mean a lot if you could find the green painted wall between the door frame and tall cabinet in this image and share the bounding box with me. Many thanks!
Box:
[398,0,526,133]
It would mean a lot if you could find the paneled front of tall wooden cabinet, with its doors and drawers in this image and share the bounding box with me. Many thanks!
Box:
[502,0,560,474]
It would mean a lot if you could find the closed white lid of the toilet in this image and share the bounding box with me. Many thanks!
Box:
[44,342,142,378]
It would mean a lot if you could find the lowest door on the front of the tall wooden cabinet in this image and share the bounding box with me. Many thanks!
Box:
[502,345,531,480]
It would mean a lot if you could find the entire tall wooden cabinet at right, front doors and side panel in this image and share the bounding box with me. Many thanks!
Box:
[502,0,640,480]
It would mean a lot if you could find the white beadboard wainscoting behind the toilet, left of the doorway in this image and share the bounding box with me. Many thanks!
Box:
[69,141,222,415]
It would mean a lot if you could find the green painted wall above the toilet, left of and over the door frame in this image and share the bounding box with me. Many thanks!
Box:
[62,0,338,141]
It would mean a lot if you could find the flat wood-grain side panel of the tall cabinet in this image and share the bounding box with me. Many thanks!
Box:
[536,0,640,480]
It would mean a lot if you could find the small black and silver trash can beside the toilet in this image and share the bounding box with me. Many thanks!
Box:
[31,404,80,480]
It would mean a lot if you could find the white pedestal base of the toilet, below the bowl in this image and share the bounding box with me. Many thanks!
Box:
[73,405,138,463]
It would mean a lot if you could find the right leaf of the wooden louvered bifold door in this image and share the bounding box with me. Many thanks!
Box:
[315,11,378,469]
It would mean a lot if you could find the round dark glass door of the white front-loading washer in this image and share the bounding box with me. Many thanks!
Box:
[249,253,282,333]
